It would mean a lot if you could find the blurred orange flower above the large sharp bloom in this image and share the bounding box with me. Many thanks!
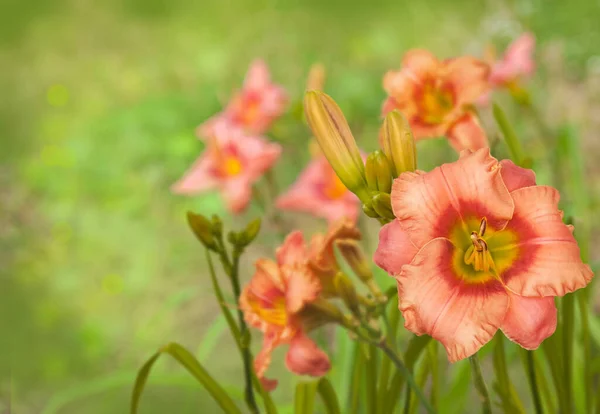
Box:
[383,49,490,151]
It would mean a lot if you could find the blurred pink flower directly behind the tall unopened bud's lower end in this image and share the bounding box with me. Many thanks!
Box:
[276,156,360,223]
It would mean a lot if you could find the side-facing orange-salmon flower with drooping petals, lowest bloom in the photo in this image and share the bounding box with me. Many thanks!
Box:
[240,231,330,389]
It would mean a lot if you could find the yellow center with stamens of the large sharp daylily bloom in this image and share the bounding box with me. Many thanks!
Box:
[450,217,519,283]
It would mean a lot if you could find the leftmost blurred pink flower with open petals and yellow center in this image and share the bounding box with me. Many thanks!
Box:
[173,122,281,213]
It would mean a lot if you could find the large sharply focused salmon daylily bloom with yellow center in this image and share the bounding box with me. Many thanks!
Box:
[374,149,593,362]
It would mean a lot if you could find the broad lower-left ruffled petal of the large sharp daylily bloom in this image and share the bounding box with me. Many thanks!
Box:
[396,238,509,362]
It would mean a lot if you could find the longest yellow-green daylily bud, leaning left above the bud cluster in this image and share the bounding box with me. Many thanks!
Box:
[304,91,369,201]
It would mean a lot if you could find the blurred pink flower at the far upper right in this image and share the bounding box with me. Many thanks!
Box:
[478,33,535,105]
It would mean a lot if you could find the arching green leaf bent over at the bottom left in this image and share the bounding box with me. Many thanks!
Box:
[131,342,241,414]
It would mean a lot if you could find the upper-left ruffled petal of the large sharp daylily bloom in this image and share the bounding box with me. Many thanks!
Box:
[392,148,513,248]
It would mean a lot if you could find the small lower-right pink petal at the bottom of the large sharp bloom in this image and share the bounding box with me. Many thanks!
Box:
[500,293,556,349]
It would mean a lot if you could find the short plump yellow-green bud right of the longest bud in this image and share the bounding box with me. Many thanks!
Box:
[379,110,417,177]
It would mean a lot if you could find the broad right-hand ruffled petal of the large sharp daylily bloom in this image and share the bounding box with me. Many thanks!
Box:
[501,186,593,297]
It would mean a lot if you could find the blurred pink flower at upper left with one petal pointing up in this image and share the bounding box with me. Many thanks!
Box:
[196,60,288,137]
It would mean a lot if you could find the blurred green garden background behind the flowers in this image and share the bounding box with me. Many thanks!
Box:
[0,0,600,414]
